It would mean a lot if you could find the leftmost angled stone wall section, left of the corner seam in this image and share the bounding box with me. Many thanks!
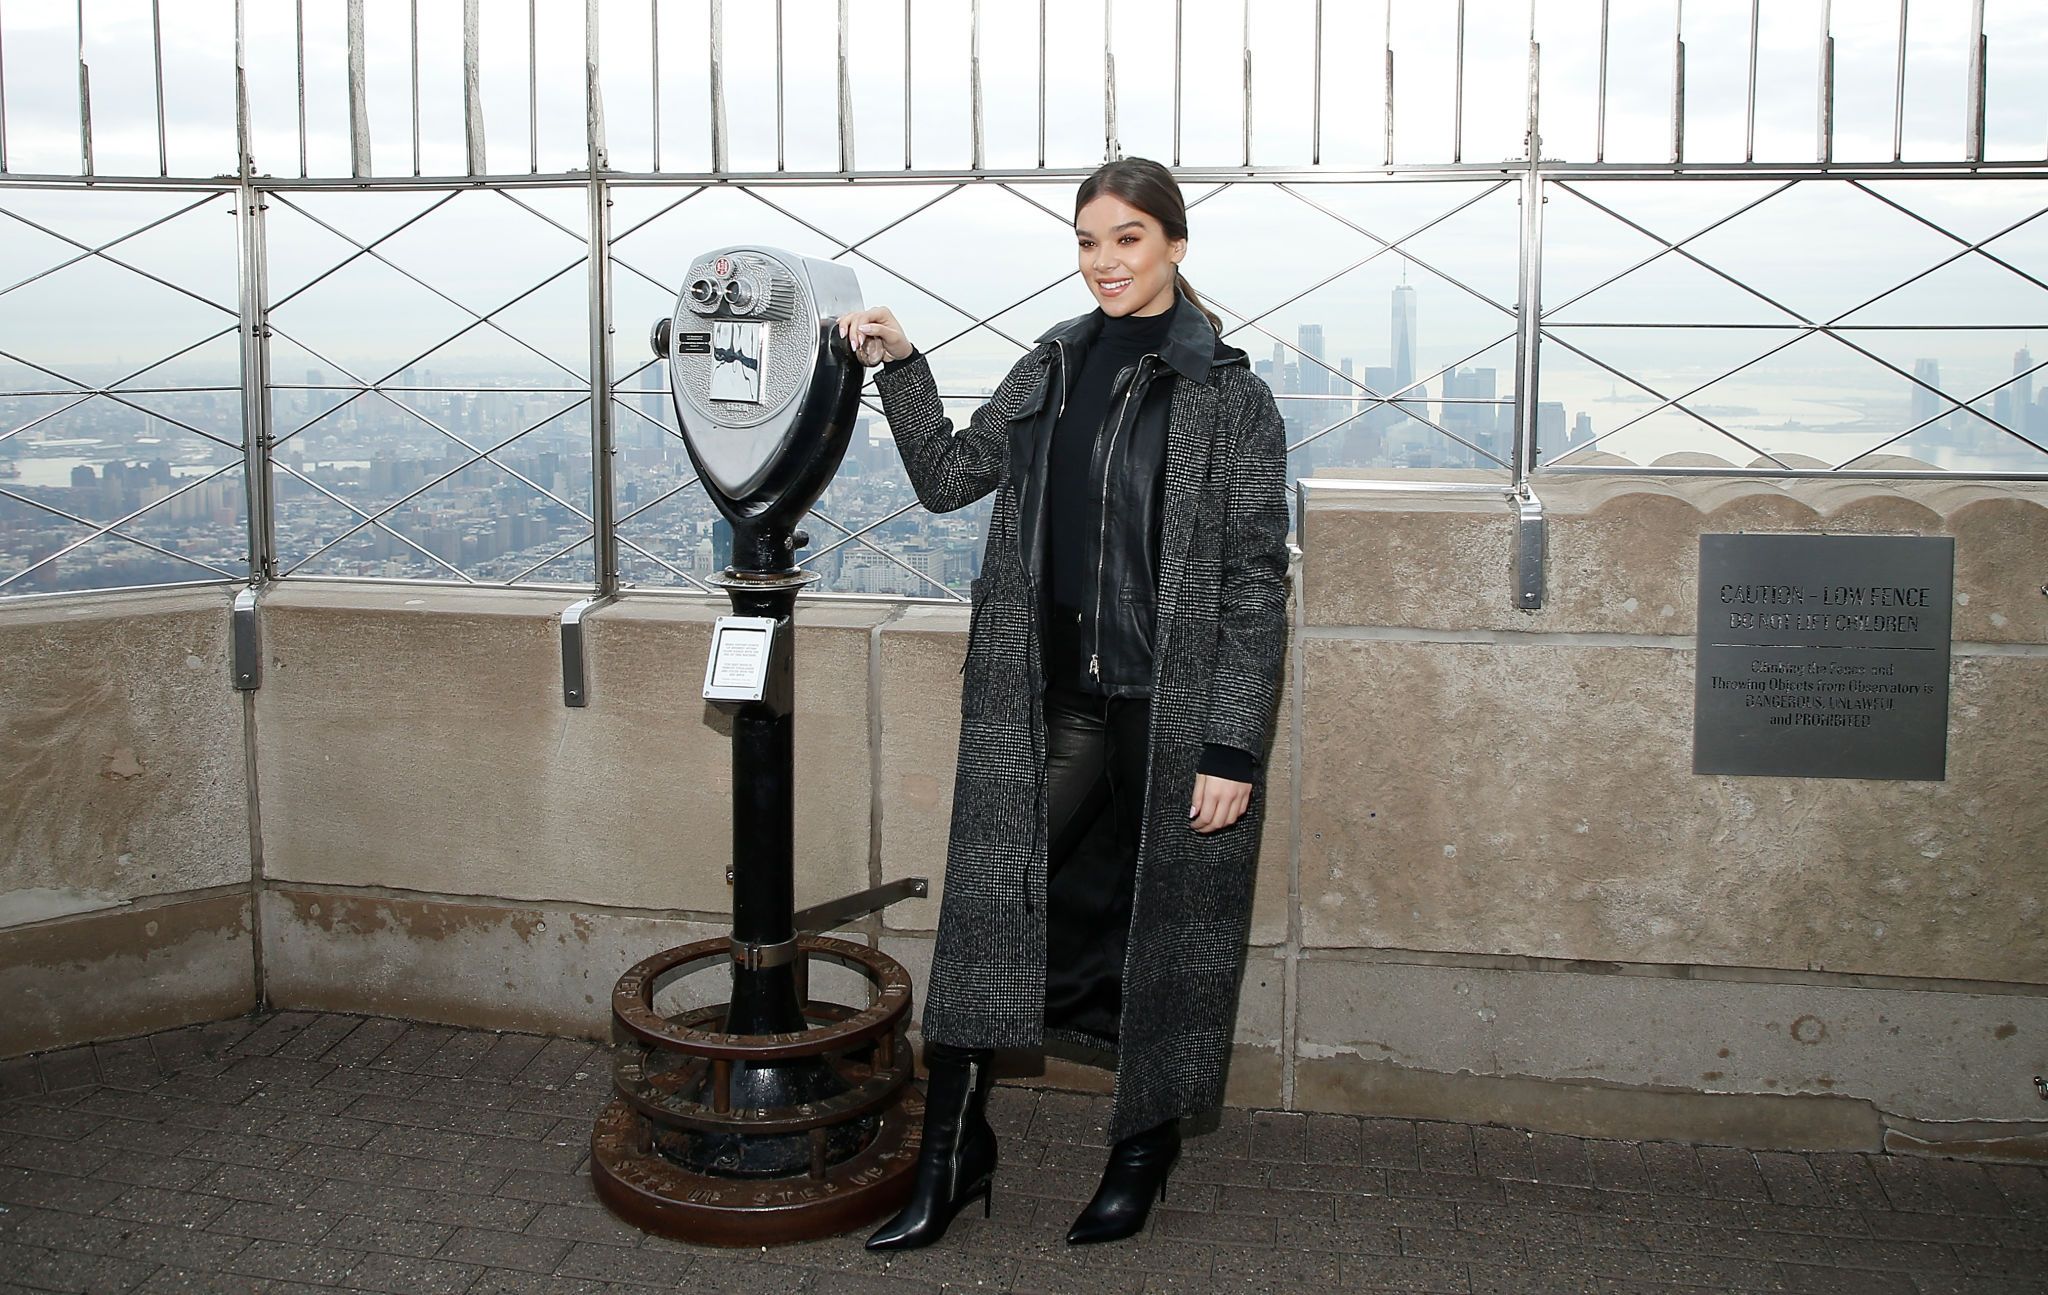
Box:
[0,588,256,1055]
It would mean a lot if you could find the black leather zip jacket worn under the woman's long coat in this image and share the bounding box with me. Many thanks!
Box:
[1018,301,1249,697]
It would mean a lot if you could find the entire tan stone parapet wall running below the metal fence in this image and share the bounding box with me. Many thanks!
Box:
[0,477,2048,1156]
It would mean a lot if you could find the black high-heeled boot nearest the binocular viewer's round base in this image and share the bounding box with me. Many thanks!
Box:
[868,1043,995,1250]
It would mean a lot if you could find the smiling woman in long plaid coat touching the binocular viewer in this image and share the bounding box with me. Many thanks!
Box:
[840,158,1286,1250]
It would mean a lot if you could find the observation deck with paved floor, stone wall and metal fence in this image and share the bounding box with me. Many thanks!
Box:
[0,0,2048,1293]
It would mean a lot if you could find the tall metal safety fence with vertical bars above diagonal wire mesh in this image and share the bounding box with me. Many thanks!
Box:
[0,0,2048,598]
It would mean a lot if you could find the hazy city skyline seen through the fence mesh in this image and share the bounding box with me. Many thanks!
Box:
[0,260,2048,596]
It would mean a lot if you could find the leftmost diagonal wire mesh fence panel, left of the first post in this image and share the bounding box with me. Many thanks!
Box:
[0,193,246,596]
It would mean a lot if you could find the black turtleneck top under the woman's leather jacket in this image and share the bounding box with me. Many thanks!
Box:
[1044,309,1180,622]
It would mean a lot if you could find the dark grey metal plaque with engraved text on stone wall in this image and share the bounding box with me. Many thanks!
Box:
[1692,535,1956,779]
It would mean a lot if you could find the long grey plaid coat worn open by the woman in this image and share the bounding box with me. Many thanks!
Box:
[877,313,1286,1137]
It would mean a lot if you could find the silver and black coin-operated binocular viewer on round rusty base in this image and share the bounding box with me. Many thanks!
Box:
[592,246,926,1246]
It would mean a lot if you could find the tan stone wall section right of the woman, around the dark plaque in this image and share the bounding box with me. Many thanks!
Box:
[1292,477,2048,1152]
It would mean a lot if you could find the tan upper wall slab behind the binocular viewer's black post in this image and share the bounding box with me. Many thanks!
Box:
[256,586,887,914]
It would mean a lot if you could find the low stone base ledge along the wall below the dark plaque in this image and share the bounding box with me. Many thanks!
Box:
[1296,955,2048,1145]
